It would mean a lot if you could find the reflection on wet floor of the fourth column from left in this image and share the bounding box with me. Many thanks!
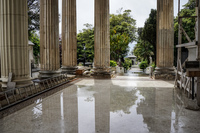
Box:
[95,86,110,133]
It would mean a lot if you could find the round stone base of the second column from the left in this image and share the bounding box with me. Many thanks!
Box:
[38,71,61,79]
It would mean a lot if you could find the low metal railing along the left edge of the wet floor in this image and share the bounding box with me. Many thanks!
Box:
[0,74,68,111]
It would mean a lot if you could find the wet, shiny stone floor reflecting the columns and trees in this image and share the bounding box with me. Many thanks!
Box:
[0,69,200,133]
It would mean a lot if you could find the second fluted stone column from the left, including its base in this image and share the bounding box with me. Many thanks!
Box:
[39,0,60,78]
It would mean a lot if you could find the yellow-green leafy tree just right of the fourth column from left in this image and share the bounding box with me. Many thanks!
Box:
[110,8,136,61]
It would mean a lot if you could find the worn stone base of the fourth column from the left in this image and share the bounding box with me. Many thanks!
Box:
[92,67,111,79]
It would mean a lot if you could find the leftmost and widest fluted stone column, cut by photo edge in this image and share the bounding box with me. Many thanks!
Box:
[0,0,32,87]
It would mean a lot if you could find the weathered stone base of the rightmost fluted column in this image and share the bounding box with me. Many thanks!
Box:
[153,67,175,80]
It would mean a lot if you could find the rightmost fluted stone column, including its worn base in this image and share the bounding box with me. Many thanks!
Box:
[154,0,174,79]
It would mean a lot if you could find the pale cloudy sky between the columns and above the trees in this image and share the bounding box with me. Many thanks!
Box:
[59,0,188,49]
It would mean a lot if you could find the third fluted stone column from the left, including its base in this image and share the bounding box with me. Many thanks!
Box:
[62,0,77,74]
